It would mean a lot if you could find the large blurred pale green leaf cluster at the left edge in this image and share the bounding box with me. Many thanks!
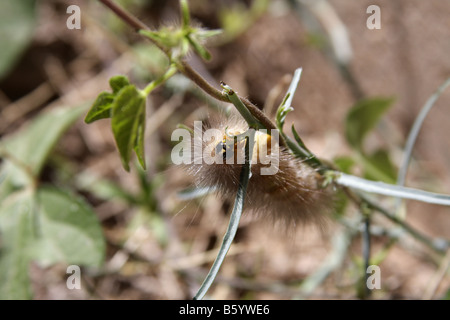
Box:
[0,105,105,299]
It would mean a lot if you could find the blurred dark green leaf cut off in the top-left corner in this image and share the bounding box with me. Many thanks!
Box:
[0,0,36,78]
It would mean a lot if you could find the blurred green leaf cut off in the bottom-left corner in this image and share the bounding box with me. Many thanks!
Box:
[0,190,34,300]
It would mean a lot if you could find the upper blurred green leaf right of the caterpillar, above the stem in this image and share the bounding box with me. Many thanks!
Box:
[345,98,394,150]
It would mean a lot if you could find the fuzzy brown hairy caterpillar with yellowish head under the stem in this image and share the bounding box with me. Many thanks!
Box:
[187,115,332,227]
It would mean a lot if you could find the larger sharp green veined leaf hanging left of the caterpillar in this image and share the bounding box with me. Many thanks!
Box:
[111,85,145,171]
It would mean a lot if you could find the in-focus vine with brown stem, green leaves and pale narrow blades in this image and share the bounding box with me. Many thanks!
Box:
[86,0,450,299]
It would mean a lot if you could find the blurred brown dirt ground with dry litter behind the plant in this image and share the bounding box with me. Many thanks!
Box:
[0,0,450,299]
